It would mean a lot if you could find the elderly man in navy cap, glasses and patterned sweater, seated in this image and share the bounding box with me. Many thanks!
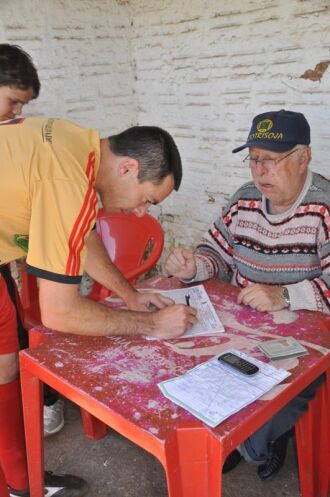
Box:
[165,110,330,480]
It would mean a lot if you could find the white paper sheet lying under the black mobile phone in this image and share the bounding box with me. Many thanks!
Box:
[158,349,291,428]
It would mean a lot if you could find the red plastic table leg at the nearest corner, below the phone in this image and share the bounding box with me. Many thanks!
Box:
[163,427,222,497]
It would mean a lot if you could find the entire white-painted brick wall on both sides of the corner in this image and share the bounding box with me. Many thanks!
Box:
[0,0,330,262]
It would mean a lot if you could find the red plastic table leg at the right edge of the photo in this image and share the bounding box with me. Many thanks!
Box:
[296,374,330,497]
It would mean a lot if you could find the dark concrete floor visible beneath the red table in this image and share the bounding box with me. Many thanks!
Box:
[45,402,300,497]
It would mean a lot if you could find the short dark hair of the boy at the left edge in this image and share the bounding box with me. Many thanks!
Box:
[0,43,40,98]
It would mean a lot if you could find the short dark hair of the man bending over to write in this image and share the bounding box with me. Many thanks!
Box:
[108,126,182,190]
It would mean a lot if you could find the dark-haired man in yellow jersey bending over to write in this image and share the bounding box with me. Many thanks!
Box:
[0,114,196,497]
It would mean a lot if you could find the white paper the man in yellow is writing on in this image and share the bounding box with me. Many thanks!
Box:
[150,285,225,338]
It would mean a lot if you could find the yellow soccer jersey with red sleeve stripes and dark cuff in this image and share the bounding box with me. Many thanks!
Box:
[0,117,100,283]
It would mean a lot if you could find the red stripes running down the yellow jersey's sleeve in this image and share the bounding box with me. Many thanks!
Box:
[65,152,97,276]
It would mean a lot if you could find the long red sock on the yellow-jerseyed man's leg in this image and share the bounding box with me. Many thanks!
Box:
[0,379,29,491]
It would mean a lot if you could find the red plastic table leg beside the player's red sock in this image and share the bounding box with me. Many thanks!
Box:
[21,357,44,497]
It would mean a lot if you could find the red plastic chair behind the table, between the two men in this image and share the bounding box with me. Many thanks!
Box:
[89,209,164,300]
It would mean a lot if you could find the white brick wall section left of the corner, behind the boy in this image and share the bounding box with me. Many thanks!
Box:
[0,0,136,135]
